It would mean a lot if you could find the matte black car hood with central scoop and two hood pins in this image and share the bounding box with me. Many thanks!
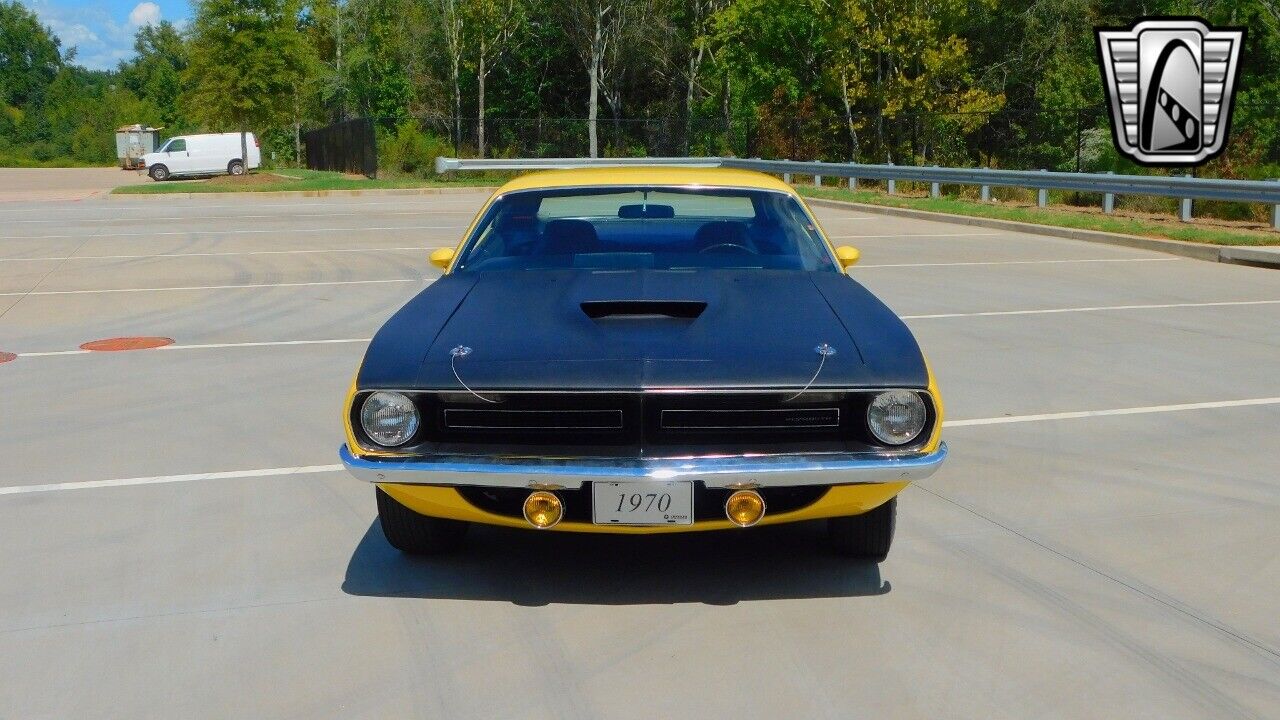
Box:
[360,269,924,389]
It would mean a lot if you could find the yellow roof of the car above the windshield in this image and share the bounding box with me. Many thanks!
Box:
[497,165,795,195]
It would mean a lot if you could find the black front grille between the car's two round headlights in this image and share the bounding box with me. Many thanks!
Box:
[352,389,934,457]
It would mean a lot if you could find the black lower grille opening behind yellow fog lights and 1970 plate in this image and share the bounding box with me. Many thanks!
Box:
[458,482,831,523]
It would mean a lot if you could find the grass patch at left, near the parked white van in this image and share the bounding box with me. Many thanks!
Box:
[111,169,495,195]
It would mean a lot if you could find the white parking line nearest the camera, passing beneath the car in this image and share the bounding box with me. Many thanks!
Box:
[0,397,1280,495]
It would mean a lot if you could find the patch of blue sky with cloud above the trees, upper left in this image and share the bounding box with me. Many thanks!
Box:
[19,0,191,69]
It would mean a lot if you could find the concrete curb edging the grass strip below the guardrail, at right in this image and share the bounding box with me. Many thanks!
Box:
[804,197,1280,268]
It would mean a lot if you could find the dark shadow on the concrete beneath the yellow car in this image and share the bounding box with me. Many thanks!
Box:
[342,520,891,606]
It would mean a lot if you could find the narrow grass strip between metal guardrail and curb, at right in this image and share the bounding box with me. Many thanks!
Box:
[796,186,1280,245]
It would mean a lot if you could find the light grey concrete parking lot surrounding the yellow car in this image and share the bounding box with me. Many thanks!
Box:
[0,185,1280,720]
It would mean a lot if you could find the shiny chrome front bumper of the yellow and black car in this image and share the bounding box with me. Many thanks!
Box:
[338,443,947,489]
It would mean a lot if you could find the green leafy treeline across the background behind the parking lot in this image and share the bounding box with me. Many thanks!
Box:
[0,0,1280,174]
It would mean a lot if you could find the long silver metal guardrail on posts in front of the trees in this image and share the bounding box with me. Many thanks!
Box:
[435,158,1280,231]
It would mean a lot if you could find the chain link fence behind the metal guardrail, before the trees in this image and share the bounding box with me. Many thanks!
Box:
[376,105,1280,177]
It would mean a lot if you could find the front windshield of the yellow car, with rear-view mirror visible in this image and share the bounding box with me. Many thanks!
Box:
[454,187,836,272]
